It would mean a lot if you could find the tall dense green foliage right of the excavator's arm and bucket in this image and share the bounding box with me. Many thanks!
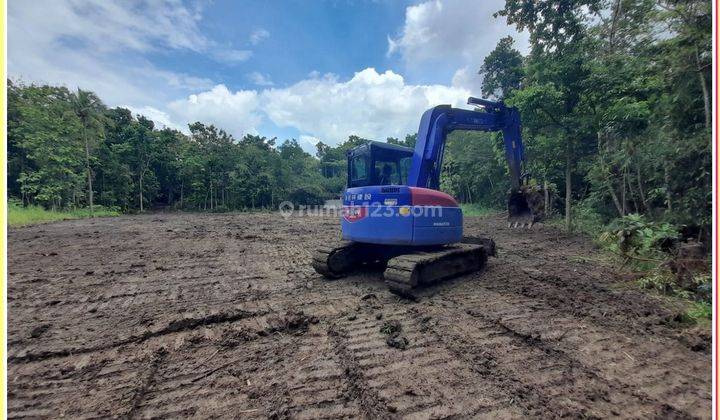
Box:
[490,0,712,236]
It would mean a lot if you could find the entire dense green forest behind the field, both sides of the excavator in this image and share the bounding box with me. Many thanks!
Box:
[8,0,712,240]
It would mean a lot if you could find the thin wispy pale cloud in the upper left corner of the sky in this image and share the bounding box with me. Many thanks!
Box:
[8,0,247,109]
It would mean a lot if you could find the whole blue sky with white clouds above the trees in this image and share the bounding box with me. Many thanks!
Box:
[7,0,528,154]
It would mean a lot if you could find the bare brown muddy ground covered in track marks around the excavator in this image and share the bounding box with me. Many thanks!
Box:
[8,214,711,418]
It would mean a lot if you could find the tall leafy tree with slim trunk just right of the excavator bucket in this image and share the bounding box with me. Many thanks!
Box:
[498,0,601,230]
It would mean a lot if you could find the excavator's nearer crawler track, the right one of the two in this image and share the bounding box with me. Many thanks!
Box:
[385,243,488,298]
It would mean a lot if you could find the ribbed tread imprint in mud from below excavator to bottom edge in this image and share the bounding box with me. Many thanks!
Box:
[324,304,521,418]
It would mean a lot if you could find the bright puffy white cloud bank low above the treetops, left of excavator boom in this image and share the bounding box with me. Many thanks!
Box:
[153,68,470,147]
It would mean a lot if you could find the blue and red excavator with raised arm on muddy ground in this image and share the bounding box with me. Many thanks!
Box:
[312,97,544,297]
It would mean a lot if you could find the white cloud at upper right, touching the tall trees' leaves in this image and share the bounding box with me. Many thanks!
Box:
[387,0,529,92]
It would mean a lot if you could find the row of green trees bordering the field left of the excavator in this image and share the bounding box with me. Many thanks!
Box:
[8,81,354,212]
